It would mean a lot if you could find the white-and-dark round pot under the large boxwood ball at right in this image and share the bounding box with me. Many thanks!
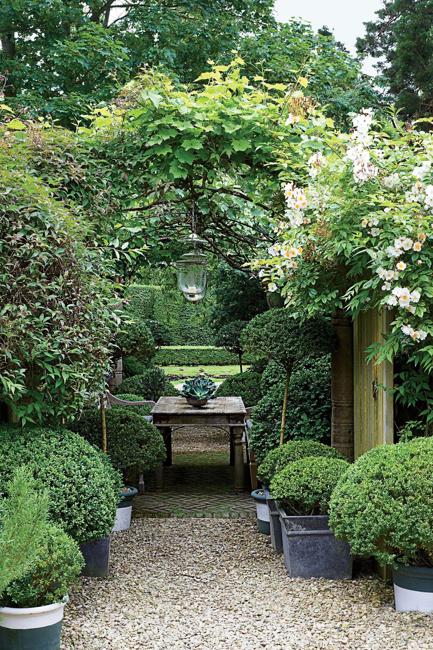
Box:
[393,564,433,614]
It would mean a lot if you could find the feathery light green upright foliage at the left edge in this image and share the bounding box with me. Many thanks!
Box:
[0,466,48,598]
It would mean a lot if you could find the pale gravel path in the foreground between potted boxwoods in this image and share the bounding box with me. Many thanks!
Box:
[62,519,433,650]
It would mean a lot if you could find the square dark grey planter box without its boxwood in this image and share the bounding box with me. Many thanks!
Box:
[280,510,352,580]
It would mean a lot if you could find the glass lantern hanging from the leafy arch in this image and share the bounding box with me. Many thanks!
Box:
[176,233,207,302]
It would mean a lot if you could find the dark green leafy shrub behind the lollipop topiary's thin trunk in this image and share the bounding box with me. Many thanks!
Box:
[249,357,331,462]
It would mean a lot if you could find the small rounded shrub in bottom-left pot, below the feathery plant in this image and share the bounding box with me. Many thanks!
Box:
[1,524,84,607]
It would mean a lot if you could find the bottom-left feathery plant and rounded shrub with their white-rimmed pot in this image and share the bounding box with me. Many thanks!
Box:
[0,468,83,650]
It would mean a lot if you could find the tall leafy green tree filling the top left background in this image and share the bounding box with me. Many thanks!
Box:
[0,0,273,124]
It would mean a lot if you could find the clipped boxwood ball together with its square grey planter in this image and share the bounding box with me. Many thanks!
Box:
[270,457,352,579]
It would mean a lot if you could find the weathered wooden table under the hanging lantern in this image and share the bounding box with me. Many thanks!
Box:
[152,397,247,491]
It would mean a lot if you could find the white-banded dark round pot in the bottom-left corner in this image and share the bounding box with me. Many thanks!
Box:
[0,598,67,650]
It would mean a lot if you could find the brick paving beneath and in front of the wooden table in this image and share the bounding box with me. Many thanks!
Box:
[134,429,255,519]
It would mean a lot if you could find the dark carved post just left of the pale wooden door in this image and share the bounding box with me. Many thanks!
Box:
[331,312,354,460]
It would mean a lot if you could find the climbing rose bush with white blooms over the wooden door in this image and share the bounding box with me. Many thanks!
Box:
[252,109,433,419]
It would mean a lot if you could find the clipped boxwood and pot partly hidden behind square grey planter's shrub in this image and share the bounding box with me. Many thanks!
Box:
[257,440,344,553]
